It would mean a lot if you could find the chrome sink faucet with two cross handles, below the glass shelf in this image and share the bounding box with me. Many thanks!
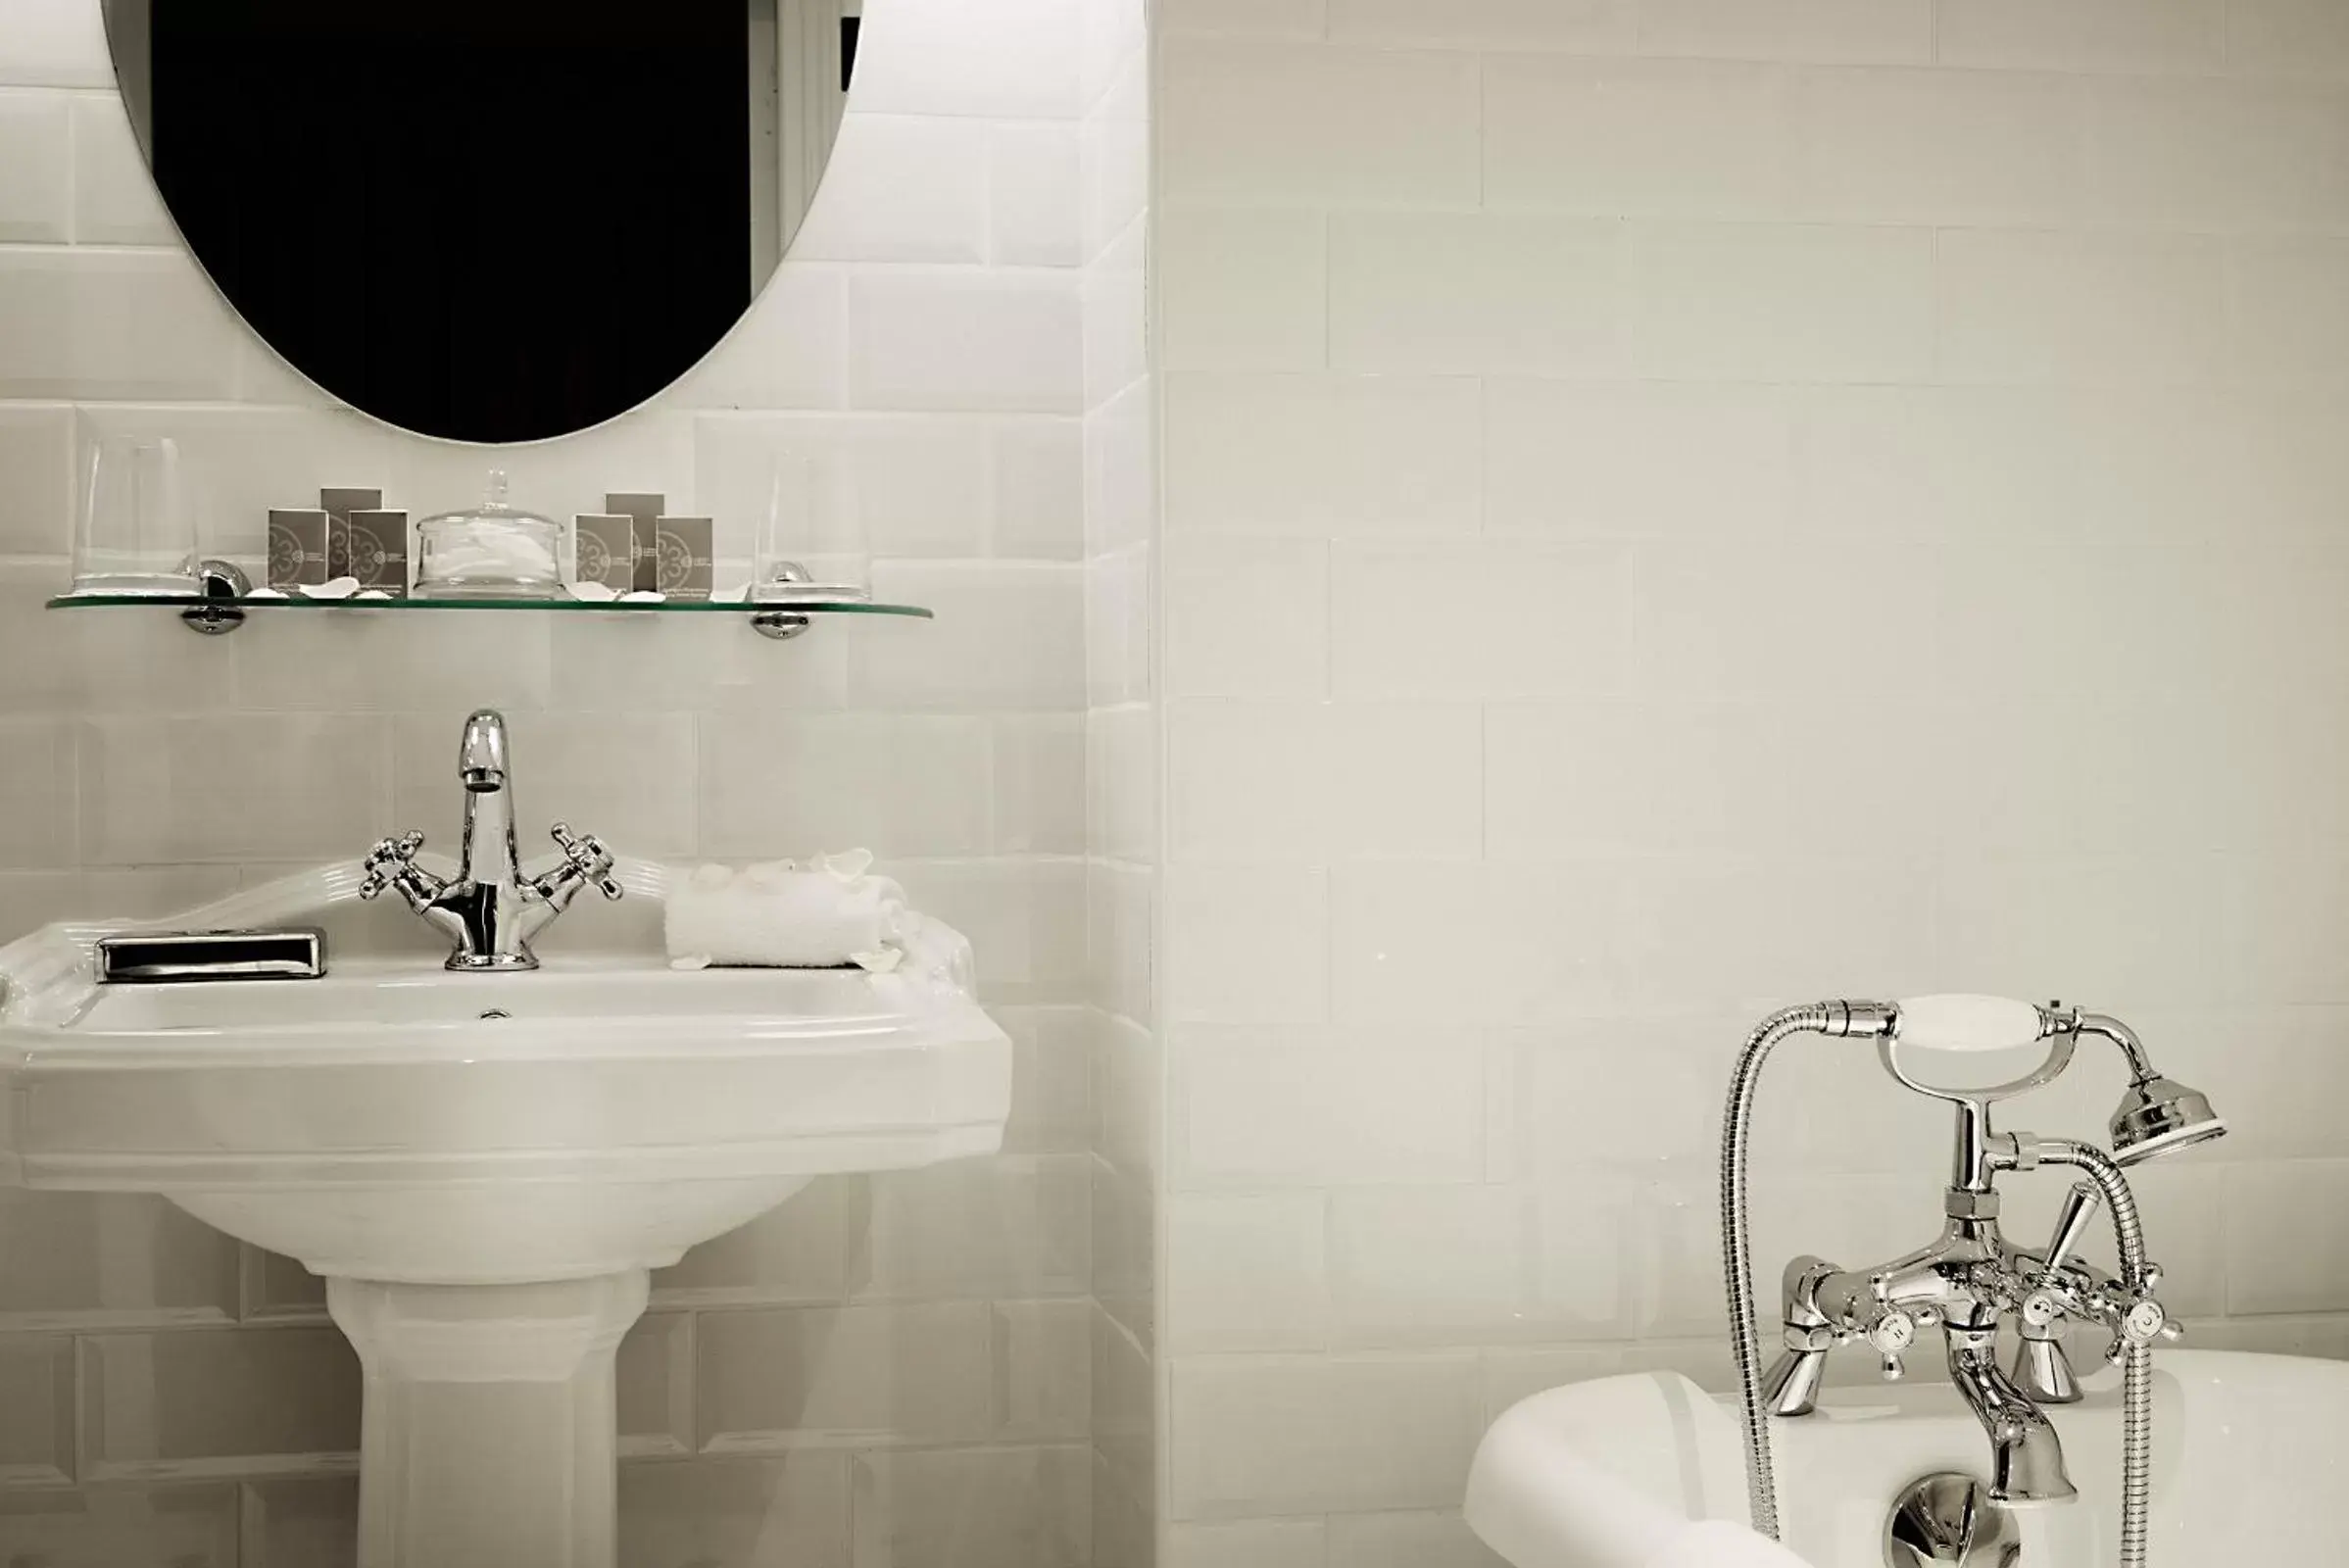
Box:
[360,709,620,972]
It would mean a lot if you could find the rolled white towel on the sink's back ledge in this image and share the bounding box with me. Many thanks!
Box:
[662,850,906,969]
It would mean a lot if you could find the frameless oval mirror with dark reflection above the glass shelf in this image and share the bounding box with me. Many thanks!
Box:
[106,0,862,441]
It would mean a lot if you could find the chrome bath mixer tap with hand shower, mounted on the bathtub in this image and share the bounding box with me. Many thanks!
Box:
[1722,998,2225,1568]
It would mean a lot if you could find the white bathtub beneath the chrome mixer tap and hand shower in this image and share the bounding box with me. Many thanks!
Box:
[1466,1349,2349,1568]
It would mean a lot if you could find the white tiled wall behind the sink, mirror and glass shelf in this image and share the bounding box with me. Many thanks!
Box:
[0,0,1158,1568]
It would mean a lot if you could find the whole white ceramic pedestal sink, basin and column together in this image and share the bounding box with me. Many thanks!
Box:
[0,866,1010,1568]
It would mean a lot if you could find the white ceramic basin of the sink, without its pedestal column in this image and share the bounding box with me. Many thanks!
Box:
[0,957,1010,1284]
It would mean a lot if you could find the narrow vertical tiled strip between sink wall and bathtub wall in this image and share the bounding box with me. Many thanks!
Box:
[1080,0,1155,1568]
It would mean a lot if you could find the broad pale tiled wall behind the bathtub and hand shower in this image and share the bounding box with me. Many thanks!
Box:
[1160,0,2349,1568]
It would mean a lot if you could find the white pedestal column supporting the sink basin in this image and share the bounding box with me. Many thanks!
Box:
[326,1270,649,1568]
